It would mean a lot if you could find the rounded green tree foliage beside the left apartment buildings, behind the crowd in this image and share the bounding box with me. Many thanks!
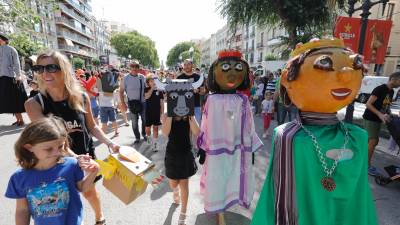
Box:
[111,31,160,68]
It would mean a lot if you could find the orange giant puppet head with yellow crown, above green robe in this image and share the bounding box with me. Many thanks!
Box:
[281,39,363,113]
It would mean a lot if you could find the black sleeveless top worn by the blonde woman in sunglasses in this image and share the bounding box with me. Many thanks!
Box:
[34,93,95,158]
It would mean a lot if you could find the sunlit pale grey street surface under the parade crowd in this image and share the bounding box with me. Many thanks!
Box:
[0,106,400,225]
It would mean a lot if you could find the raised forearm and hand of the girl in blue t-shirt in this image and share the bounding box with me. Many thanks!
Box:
[77,155,99,192]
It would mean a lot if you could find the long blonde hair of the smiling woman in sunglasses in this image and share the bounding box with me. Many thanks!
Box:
[36,50,85,112]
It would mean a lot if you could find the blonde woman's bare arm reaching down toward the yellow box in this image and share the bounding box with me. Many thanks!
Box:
[85,95,120,152]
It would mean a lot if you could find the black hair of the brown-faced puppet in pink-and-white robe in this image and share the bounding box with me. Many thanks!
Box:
[207,57,251,93]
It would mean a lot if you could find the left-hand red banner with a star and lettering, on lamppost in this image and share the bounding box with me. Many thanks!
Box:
[334,16,361,52]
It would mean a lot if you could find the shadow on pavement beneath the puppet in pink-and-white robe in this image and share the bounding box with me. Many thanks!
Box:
[195,212,251,225]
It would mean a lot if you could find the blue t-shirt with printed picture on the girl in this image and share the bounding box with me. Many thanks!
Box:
[5,157,83,225]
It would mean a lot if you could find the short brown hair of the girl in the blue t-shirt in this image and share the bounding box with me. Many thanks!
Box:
[14,117,68,169]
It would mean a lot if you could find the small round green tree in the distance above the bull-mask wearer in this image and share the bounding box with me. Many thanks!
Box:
[167,41,201,67]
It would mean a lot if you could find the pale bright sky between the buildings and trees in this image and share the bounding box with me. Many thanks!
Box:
[91,0,226,65]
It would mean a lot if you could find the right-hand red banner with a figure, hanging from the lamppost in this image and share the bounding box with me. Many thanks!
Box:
[363,20,392,64]
